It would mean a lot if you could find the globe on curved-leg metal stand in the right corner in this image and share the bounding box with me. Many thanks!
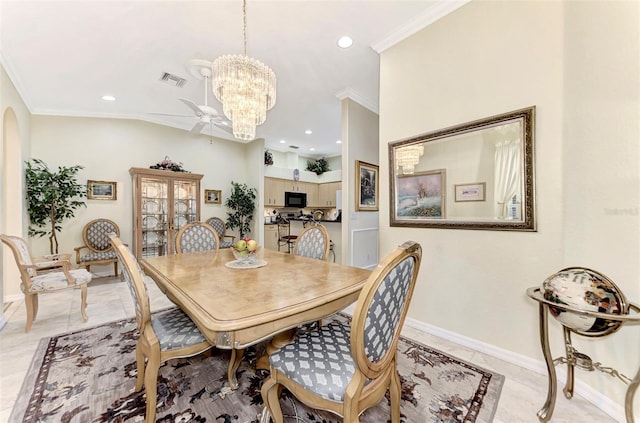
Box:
[527,267,640,423]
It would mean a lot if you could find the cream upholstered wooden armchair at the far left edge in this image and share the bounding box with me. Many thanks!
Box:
[0,235,91,332]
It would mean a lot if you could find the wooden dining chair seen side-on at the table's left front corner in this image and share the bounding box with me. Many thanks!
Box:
[110,235,212,423]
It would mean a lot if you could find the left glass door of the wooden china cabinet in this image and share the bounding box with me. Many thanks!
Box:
[140,178,169,257]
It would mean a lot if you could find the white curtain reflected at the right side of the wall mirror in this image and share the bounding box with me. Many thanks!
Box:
[494,138,521,219]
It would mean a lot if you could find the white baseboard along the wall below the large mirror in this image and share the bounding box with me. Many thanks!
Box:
[405,318,626,422]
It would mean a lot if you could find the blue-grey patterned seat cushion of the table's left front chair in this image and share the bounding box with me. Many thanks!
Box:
[151,308,206,351]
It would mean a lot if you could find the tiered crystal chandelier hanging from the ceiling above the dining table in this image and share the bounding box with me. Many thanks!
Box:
[211,0,276,141]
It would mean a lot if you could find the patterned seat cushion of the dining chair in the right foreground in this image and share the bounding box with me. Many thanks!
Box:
[269,322,355,401]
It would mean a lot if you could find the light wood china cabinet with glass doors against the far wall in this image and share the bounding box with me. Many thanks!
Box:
[129,168,203,259]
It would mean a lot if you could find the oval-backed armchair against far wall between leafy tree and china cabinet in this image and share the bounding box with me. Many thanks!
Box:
[74,219,120,276]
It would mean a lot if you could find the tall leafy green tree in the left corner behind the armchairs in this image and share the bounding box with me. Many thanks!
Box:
[25,159,87,254]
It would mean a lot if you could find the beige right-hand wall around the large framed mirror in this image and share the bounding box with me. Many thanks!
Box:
[380,1,640,418]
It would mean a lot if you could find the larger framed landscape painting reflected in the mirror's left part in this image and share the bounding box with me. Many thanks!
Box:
[391,169,446,226]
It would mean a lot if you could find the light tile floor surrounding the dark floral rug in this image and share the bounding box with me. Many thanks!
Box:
[0,277,615,423]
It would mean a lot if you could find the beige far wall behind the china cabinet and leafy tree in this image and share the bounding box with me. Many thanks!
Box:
[30,116,252,273]
